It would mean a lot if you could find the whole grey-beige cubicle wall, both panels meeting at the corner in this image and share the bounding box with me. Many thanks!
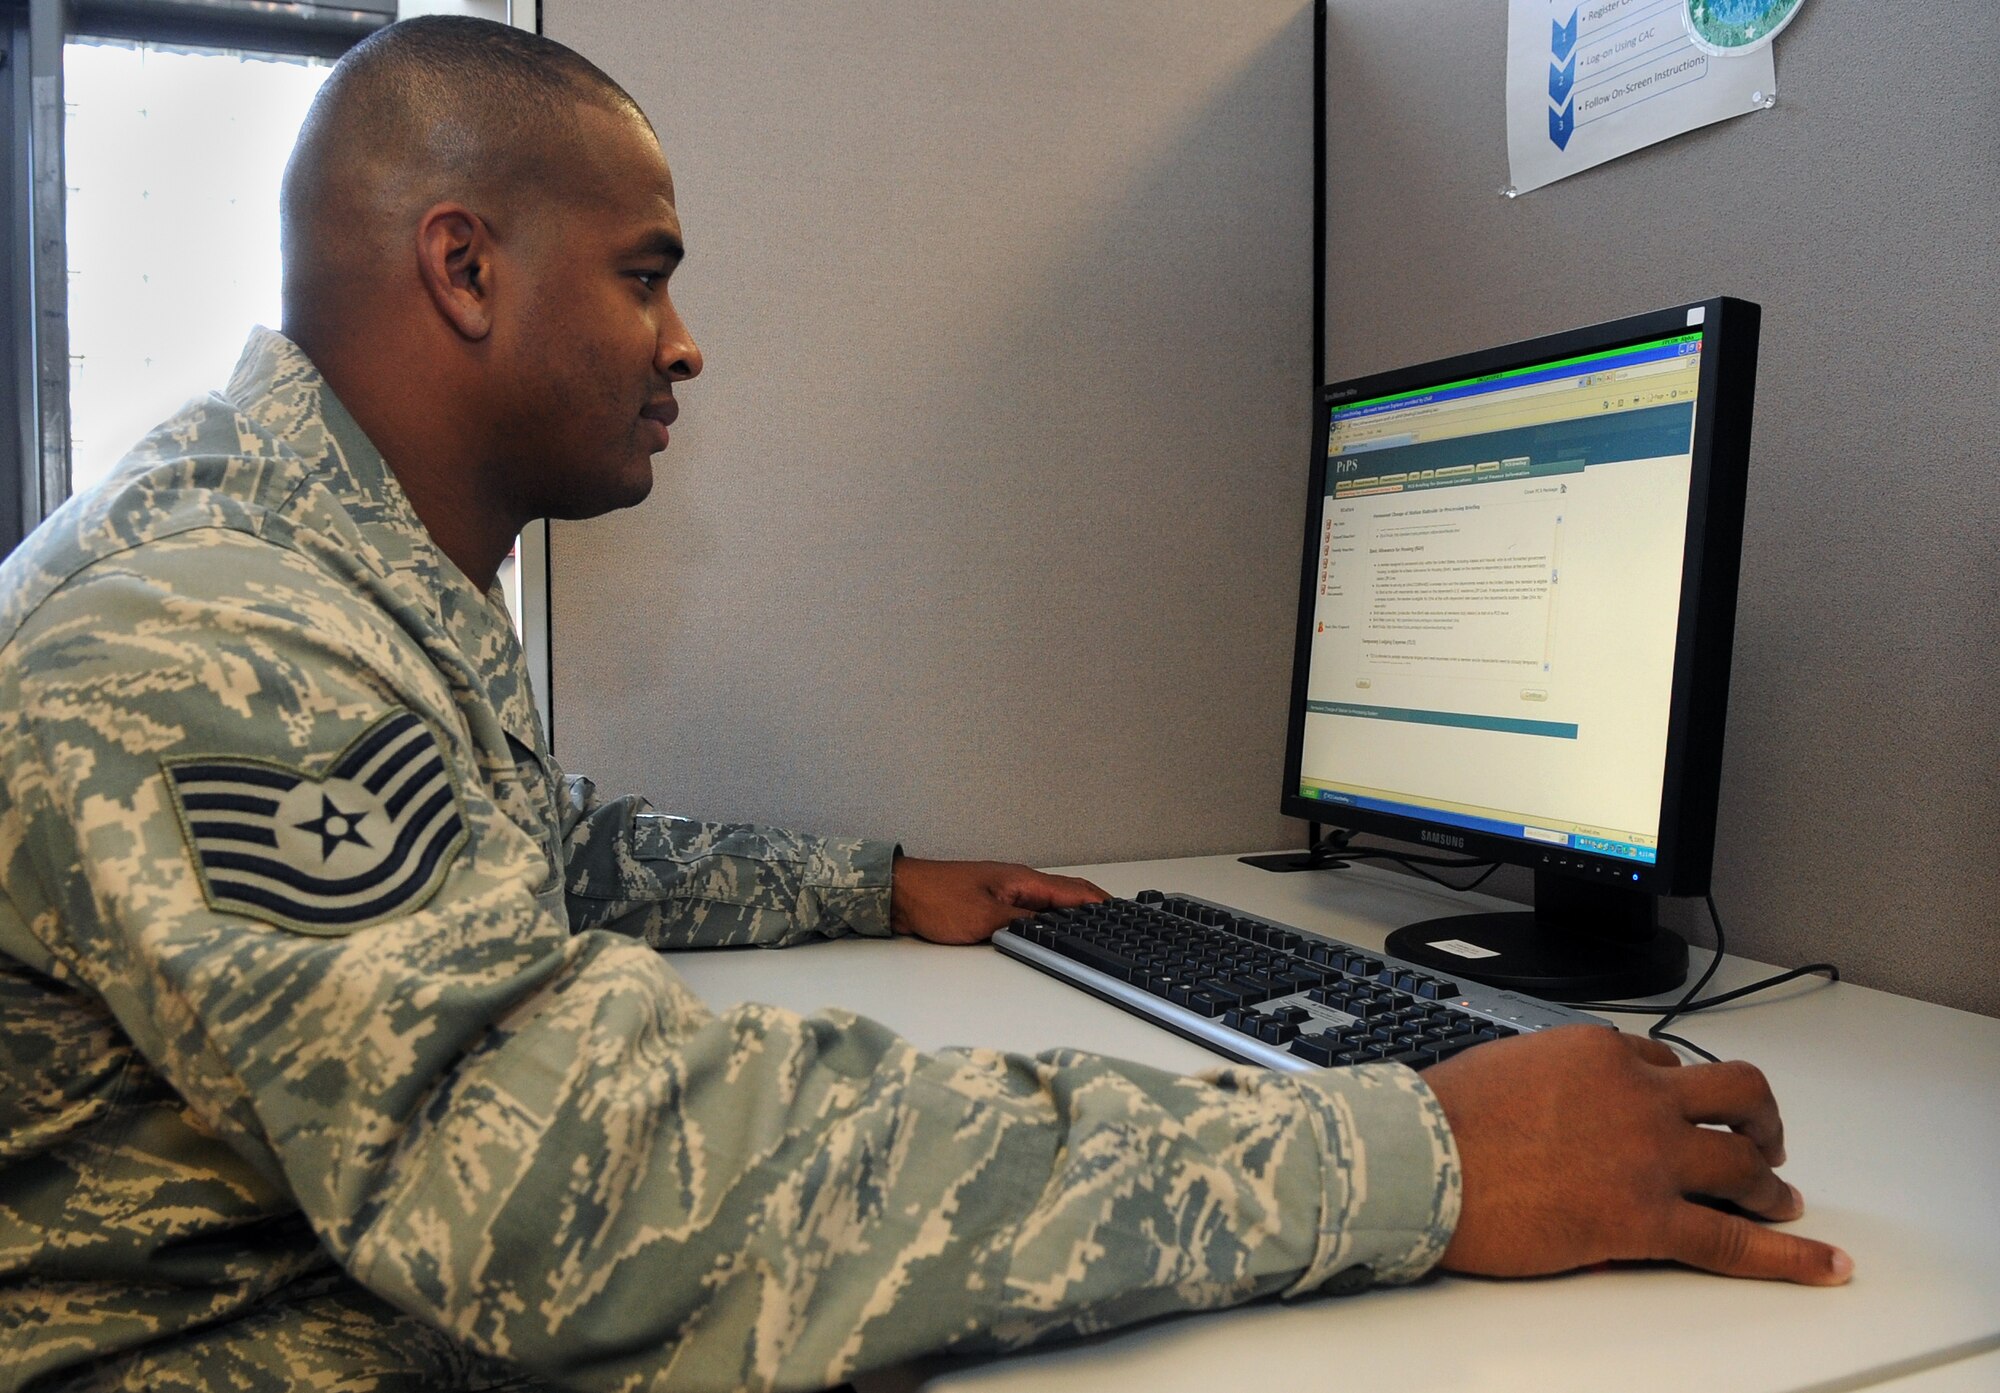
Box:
[546,0,2000,1013]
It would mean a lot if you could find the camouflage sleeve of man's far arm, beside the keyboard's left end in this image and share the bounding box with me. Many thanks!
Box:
[556,777,896,949]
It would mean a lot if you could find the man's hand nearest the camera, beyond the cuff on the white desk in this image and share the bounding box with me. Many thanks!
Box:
[1424,1025,1854,1287]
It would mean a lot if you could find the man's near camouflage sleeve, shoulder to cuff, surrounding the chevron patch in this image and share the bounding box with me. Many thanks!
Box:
[0,534,1458,1389]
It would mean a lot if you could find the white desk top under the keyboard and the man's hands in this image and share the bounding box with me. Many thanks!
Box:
[672,857,2000,1393]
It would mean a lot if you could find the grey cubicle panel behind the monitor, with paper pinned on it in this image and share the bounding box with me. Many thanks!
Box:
[1326,0,2000,1015]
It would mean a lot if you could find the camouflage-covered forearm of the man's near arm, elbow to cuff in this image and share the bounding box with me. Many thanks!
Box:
[344,939,1458,1389]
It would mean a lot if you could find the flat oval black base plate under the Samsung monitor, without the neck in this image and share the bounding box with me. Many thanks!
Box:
[1386,911,1688,1001]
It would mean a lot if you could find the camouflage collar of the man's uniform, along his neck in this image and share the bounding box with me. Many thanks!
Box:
[224,326,544,751]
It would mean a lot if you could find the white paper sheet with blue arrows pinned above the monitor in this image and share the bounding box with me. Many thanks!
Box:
[1504,0,1800,198]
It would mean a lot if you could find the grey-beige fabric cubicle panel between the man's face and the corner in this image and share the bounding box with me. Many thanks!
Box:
[544,0,1314,865]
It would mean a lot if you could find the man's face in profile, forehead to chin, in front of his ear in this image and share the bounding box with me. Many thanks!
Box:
[496,106,702,518]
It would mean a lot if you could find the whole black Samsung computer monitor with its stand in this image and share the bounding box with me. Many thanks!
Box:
[1284,298,1760,1001]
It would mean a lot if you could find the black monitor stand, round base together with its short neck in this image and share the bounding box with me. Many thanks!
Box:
[1386,871,1688,1001]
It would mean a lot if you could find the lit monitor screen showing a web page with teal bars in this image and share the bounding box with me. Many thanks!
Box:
[1300,332,1702,865]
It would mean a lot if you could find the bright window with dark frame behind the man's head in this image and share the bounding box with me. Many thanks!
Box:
[13,0,550,736]
